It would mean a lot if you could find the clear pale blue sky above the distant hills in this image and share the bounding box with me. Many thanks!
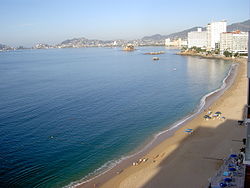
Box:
[0,0,250,47]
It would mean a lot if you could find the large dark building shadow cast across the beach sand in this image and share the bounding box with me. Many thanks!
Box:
[142,119,246,188]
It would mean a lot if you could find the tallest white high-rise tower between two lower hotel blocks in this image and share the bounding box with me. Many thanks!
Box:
[207,21,227,50]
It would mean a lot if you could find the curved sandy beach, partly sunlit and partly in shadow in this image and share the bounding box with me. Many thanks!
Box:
[79,59,247,188]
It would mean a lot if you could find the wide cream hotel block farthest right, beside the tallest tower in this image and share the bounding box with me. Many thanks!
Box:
[220,30,248,53]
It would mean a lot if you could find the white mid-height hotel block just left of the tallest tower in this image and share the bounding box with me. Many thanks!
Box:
[188,28,207,49]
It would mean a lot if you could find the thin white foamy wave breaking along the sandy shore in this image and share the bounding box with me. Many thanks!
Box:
[64,63,238,188]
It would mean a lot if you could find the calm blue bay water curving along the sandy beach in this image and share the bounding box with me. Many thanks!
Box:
[0,47,232,187]
